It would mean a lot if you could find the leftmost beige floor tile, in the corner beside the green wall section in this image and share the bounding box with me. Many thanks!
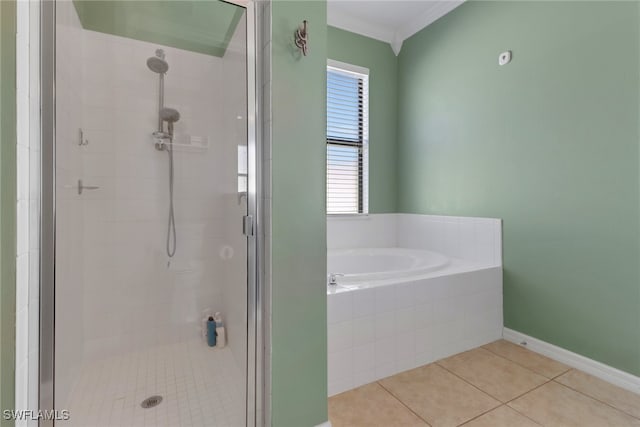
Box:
[329,383,427,427]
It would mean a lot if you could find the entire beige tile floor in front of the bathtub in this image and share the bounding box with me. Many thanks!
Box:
[329,340,640,427]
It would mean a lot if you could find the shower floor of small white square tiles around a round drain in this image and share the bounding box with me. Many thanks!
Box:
[63,340,245,427]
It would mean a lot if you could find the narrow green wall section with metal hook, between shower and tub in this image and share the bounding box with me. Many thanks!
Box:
[271,0,328,427]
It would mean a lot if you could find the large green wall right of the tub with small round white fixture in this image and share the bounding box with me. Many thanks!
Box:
[398,1,640,375]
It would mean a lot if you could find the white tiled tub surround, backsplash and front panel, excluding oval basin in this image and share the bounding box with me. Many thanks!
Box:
[327,214,503,396]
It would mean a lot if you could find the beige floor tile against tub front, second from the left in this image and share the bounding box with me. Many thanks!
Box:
[380,364,500,427]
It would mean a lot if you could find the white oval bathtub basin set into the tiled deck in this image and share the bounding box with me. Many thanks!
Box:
[327,248,450,287]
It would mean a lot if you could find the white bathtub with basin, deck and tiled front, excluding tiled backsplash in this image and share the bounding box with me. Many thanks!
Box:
[327,248,503,396]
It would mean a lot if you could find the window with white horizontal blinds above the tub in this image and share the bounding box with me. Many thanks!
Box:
[327,61,369,214]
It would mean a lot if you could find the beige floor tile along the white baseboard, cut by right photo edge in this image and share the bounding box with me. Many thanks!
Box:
[556,369,640,418]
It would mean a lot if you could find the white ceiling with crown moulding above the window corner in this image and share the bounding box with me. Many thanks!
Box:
[327,0,464,55]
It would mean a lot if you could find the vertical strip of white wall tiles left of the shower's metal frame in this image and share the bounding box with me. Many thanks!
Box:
[15,12,40,412]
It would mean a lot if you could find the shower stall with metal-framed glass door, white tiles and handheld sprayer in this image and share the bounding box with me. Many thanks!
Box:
[40,0,262,427]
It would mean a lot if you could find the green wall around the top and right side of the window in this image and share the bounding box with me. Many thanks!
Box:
[327,27,398,213]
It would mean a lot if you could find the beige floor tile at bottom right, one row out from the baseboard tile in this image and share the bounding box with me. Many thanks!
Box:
[509,381,640,427]
